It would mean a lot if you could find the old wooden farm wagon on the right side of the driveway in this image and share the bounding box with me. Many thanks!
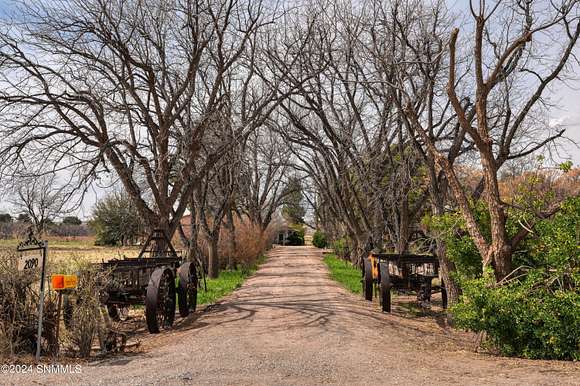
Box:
[361,253,447,312]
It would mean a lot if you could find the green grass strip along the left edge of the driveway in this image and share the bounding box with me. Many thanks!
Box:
[197,256,266,304]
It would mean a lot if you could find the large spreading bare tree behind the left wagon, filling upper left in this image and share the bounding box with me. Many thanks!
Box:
[0,0,280,243]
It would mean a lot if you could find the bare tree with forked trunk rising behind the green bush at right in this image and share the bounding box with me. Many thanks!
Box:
[404,1,580,279]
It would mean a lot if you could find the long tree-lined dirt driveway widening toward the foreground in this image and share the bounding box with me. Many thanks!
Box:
[0,247,580,385]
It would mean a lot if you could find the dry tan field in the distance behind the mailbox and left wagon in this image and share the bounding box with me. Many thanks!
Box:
[0,237,140,262]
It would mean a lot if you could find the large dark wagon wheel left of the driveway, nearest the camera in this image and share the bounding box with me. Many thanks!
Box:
[145,268,175,334]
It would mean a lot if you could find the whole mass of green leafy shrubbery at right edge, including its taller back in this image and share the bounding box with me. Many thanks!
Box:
[451,197,580,360]
